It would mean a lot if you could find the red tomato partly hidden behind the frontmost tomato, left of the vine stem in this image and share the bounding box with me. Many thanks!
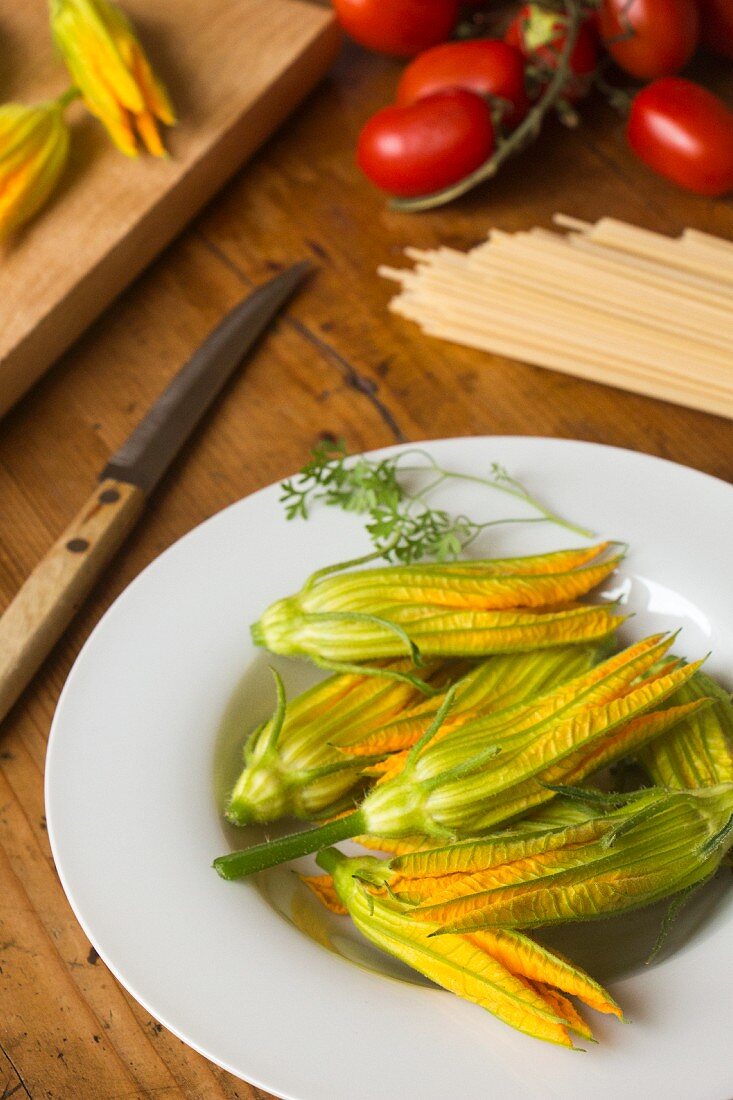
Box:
[397,39,529,129]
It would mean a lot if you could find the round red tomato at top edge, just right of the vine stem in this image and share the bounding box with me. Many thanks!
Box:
[600,0,700,80]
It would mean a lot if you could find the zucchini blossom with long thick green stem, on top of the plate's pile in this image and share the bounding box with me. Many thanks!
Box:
[214,635,709,878]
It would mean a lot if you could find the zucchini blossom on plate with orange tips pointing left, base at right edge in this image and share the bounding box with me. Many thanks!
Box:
[400,783,733,933]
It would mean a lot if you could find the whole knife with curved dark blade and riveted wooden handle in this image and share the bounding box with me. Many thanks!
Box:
[0,261,310,722]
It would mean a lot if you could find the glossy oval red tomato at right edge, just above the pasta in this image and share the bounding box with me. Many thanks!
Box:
[627,77,733,195]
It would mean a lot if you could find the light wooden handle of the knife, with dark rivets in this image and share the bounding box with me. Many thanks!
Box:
[0,480,145,722]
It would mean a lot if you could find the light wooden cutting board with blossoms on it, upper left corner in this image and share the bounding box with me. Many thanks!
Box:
[0,0,339,415]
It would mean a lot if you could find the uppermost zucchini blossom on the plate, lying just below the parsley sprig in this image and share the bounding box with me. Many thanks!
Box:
[252,542,622,671]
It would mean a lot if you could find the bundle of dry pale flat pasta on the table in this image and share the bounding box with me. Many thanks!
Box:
[380,215,733,418]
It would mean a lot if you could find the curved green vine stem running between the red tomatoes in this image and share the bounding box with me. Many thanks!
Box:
[390,0,582,213]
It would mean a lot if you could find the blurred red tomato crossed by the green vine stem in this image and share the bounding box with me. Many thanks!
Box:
[504,3,598,101]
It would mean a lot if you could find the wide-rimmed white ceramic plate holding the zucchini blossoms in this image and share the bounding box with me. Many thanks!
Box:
[46,438,733,1100]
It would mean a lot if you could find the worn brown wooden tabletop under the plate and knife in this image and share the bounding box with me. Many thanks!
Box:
[0,15,733,1100]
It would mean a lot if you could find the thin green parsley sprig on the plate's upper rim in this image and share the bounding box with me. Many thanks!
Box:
[281,440,593,564]
